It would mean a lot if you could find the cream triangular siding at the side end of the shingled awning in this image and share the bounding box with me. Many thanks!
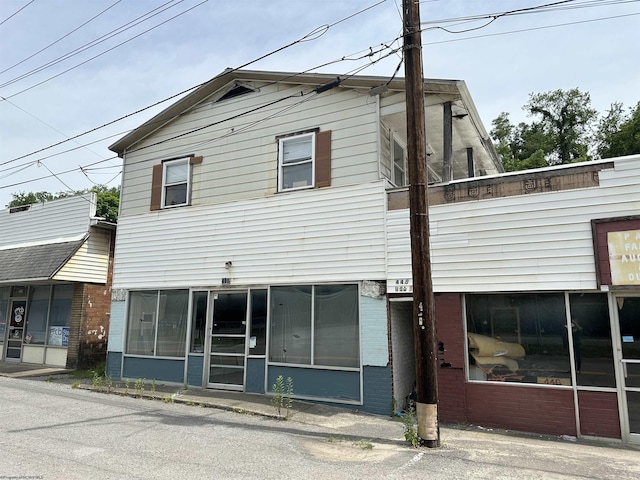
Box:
[53,231,110,283]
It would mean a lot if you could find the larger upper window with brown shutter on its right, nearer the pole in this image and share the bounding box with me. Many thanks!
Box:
[278,130,331,192]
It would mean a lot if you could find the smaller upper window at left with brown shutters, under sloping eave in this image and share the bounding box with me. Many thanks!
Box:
[151,157,202,210]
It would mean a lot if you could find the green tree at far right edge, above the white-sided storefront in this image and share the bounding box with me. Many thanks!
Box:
[597,102,640,158]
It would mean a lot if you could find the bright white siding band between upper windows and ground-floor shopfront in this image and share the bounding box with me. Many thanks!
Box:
[114,182,386,289]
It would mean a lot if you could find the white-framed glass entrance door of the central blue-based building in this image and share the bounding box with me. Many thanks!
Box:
[207,291,247,390]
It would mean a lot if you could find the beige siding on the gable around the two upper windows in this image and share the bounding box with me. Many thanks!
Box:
[120,84,379,218]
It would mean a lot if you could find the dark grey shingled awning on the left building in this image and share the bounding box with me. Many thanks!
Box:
[0,238,85,283]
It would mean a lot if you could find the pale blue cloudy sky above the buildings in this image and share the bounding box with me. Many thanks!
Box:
[0,0,640,208]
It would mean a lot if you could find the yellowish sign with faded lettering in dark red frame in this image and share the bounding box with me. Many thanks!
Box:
[607,230,640,285]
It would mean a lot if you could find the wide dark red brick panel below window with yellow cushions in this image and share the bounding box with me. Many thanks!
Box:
[465,382,577,435]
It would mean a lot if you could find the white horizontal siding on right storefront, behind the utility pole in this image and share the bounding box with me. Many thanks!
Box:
[387,157,640,293]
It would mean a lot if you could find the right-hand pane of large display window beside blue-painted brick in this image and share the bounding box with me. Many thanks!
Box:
[313,285,360,367]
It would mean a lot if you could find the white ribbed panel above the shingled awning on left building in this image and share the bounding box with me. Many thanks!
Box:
[0,193,96,248]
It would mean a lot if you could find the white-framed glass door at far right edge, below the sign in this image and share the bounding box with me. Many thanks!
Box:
[615,296,640,443]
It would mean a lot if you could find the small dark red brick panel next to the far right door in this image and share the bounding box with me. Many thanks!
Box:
[578,392,622,438]
